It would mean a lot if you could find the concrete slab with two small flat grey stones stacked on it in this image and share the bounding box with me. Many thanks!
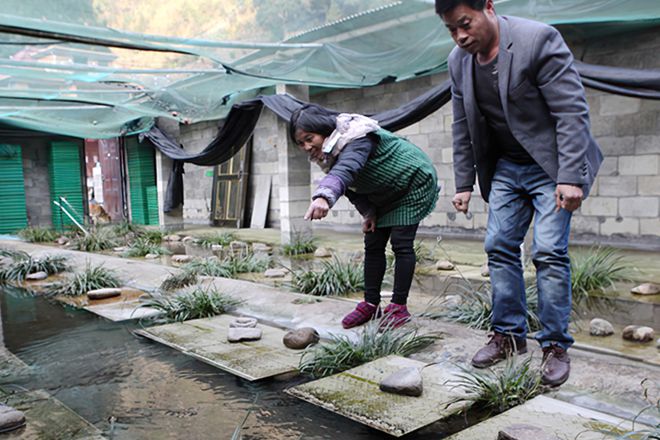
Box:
[135,315,302,381]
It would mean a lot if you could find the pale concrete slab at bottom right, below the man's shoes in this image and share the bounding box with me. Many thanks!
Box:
[447,396,648,440]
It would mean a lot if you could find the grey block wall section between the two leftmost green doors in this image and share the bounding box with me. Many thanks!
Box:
[17,142,53,227]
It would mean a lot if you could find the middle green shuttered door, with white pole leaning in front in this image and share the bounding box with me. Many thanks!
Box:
[48,141,85,230]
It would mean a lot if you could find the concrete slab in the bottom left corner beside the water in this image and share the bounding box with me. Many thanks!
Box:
[0,389,105,440]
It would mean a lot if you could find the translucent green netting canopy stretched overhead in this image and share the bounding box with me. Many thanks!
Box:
[0,0,660,138]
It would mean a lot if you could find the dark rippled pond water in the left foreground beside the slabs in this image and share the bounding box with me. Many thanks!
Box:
[0,287,464,440]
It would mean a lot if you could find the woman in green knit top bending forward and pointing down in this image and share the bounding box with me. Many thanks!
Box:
[289,104,438,329]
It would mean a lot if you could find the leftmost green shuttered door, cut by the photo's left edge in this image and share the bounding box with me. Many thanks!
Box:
[0,144,27,234]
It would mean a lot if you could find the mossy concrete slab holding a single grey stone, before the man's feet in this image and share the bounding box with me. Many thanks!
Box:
[285,356,470,438]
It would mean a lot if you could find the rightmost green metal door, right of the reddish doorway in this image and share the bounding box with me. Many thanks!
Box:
[126,138,158,225]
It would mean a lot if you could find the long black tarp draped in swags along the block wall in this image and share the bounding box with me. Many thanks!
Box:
[141,62,660,212]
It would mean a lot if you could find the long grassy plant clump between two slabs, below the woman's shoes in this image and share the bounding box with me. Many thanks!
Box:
[298,319,440,377]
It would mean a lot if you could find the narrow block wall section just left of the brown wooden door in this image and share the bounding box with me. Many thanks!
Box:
[179,121,218,225]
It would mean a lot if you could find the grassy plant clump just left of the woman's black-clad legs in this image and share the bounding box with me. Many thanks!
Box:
[291,256,364,296]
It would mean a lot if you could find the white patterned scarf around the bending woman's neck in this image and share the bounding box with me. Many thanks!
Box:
[310,113,380,174]
